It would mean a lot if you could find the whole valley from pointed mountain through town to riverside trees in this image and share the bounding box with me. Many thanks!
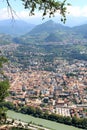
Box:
[0,21,87,128]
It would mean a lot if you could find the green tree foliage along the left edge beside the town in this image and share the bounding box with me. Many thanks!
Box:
[0,56,10,123]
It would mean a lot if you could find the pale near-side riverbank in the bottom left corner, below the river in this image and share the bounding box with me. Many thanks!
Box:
[0,118,51,130]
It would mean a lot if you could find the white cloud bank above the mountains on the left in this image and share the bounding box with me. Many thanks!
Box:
[0,8,42,22]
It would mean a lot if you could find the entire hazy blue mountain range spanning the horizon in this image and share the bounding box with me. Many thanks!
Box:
[0,20,87,44]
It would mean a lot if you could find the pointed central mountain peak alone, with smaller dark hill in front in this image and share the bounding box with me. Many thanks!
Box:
[15,20,70,43]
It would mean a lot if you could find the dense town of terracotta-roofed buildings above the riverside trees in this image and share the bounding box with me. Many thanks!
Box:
[4,60,87,117]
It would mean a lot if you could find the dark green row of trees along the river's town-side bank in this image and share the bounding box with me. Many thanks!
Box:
[0,102,87,129]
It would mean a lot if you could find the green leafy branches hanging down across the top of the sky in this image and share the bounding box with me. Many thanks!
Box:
[6,0,70,22]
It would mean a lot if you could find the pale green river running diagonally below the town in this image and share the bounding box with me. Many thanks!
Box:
[7,110,82,130]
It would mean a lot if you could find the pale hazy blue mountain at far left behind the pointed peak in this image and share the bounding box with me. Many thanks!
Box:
[0,20,35,36]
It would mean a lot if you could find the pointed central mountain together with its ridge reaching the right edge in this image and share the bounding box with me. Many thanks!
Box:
[14,20,87,44]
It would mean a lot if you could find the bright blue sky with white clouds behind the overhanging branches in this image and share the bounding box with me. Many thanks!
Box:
[0,0,87,26]
